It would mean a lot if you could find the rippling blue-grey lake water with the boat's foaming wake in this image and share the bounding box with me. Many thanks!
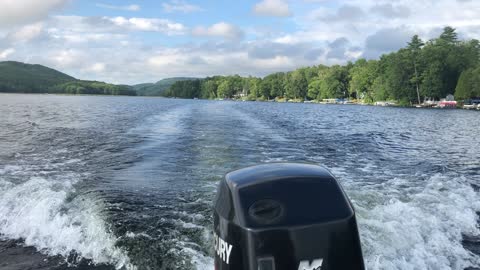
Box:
[0,94,480,270]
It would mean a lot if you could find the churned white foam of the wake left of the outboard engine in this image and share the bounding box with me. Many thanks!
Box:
[0,174,135,269]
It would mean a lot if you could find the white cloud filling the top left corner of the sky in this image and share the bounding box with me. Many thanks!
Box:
[0,0,68,28]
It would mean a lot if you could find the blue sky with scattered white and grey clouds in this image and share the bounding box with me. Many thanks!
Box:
[0,0,480,84]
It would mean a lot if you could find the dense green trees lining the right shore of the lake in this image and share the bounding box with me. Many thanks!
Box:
[165,27,480,105]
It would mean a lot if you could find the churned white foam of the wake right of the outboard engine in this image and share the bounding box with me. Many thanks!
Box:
[345,174,480,270]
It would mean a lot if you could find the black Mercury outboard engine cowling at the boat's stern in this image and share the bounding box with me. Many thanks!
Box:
[214,163,365,270]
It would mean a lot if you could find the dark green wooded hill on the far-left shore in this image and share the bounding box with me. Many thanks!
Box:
[0,61,136,95]
